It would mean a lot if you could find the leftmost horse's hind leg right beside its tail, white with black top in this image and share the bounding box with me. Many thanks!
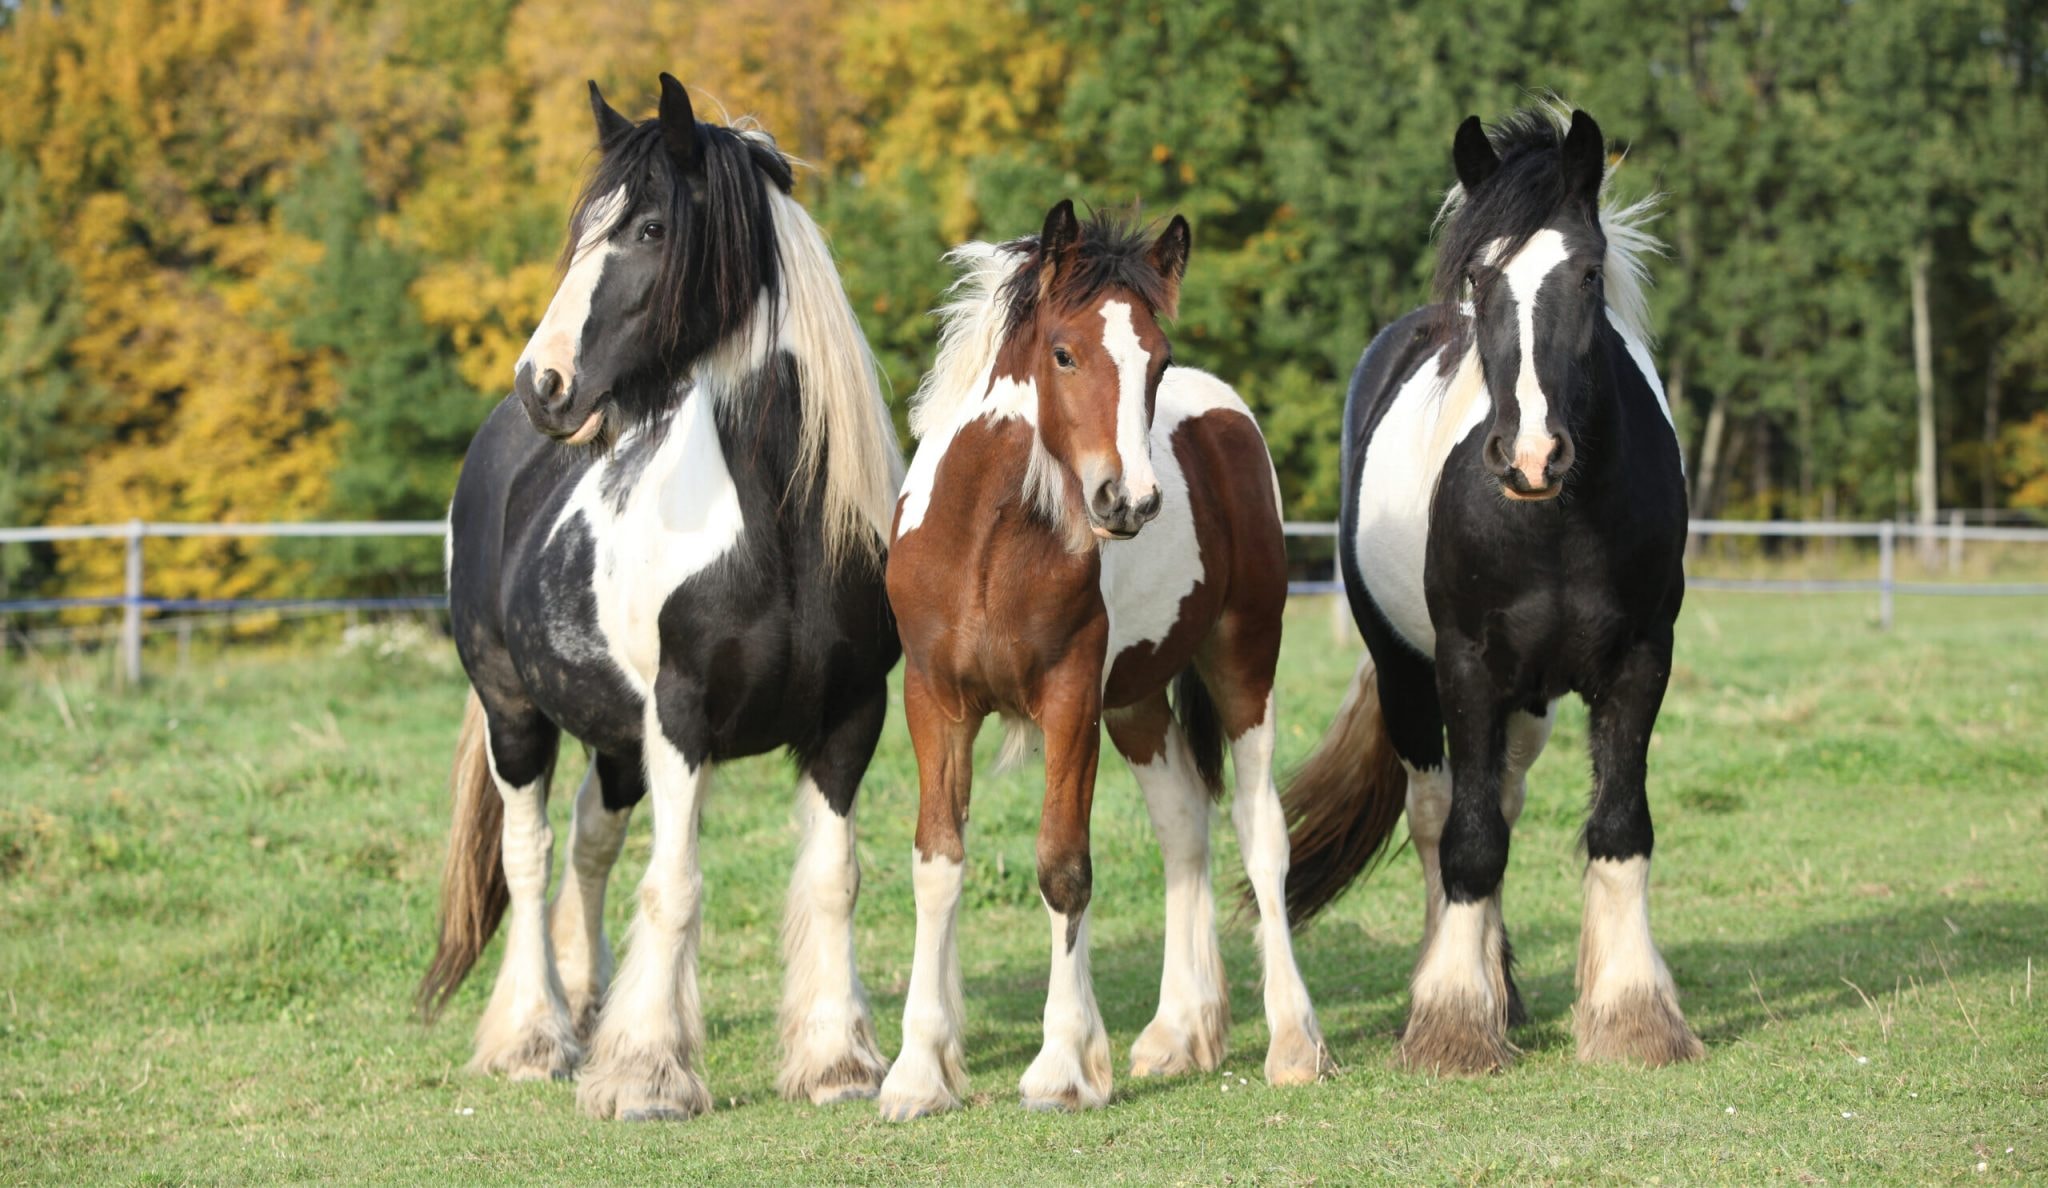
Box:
[469,713,584,1081]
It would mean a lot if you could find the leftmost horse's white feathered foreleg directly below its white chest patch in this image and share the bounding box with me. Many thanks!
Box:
[575,688,711,1120]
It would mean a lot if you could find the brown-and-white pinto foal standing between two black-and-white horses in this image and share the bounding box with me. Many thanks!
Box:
[881,203,1329,1120]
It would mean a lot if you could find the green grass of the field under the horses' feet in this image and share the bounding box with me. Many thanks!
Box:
[0,596,2048,1184]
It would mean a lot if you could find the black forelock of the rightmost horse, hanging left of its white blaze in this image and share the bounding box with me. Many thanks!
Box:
[1432,109,1597,303]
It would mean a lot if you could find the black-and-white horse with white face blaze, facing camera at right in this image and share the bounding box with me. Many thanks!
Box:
[1286,111,1702,1073]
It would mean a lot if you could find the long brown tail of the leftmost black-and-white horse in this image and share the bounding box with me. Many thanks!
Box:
[420,690,512,1022]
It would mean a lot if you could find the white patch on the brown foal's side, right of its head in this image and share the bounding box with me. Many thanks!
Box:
[1102,367,1251,680]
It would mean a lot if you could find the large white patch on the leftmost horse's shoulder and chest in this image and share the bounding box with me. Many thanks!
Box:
[549,391,745,696]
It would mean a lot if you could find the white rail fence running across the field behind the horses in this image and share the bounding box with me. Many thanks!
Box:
[0,512,2048,682]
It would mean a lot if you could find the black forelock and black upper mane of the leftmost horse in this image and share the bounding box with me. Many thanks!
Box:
[561,119,795,378]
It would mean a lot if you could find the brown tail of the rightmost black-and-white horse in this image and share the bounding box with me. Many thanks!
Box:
[1280,655,1407,924]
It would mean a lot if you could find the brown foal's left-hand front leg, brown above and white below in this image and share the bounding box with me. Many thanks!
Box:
[877,666,981,1122]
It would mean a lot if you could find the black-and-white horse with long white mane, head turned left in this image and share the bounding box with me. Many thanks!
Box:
[420,74,901,1118]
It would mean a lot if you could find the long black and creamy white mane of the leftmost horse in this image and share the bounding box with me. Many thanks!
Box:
[563,119,903,563]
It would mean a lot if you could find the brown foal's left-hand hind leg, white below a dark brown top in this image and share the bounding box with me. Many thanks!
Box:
[1104,690,1231,1077]
